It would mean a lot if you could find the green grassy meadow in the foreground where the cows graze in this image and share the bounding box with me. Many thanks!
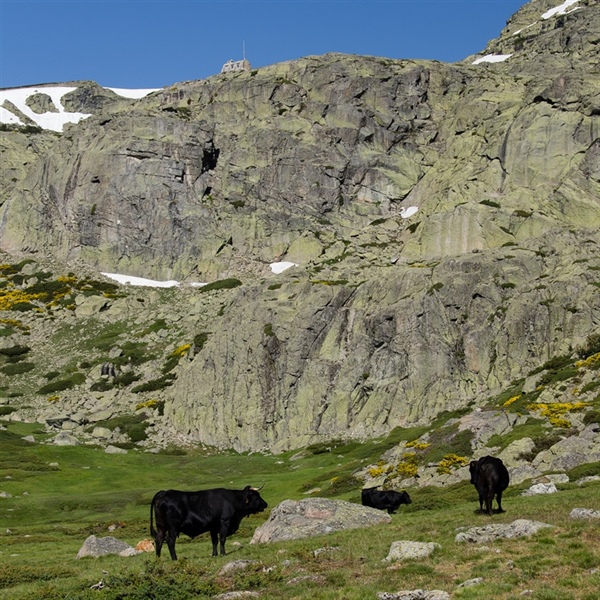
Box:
[0,422,600,600]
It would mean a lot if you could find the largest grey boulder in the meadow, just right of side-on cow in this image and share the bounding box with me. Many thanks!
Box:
[250,498,392,544]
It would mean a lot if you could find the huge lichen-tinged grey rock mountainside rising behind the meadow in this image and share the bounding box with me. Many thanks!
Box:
[0,0,600,452]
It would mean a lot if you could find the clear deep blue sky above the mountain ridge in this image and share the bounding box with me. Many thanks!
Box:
[0,0,528,88]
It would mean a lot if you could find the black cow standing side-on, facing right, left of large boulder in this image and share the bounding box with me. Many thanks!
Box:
[150,485,267,560]
